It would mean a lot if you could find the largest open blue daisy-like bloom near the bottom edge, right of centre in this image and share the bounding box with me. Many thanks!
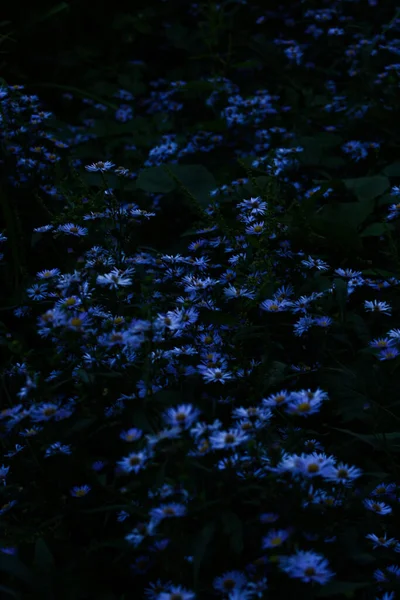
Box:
[279,550,334,585]
